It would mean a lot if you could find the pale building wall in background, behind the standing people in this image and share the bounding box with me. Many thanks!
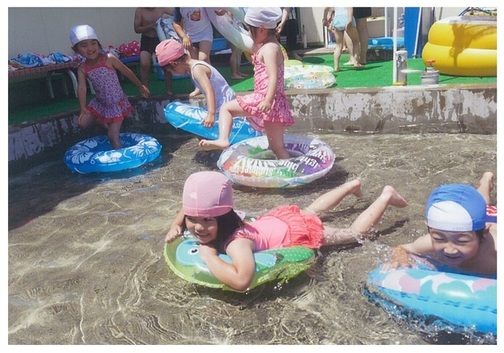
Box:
[8,7,464,58]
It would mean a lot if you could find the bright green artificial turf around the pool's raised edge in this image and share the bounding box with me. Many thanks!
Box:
[9,53,497,125]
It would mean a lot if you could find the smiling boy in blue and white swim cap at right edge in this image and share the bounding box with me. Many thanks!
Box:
[386,172,497,274]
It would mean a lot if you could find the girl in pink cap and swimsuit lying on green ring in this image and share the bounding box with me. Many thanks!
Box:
[165,171,408,291]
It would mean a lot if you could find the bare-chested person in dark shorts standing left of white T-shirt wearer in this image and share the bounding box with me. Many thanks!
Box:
[133,7,173,96]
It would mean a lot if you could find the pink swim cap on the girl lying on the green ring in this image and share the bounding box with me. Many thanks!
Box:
[182,171,233,217]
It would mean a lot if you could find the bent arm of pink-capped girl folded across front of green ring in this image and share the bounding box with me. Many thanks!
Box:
[200,238,255,291]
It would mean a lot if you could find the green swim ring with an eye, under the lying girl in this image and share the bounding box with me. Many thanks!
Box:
[164,234,315,292]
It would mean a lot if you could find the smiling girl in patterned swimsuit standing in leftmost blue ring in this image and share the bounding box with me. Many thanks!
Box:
[70,25,150,149]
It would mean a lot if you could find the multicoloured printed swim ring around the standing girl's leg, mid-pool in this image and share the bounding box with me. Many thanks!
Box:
[217,135,335,188]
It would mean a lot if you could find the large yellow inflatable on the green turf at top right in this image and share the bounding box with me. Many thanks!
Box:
[422,16,497,76]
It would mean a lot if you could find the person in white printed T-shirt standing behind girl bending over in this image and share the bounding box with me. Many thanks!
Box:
[173,7,213,97]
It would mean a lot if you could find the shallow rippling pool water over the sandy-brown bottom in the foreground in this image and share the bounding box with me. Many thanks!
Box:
[8,134,497,345]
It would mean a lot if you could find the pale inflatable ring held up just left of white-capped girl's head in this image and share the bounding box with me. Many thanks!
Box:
[205,7,254,53]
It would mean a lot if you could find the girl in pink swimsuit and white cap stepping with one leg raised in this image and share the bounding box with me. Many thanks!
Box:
[199,7,294,159]
